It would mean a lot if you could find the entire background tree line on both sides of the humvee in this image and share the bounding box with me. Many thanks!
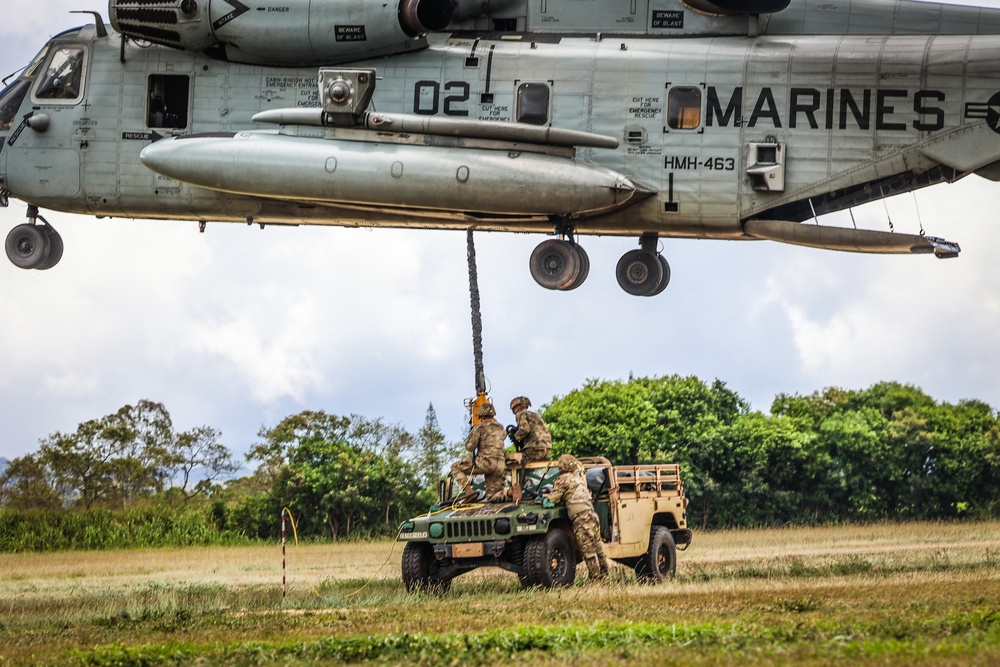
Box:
[0,375,1000,551]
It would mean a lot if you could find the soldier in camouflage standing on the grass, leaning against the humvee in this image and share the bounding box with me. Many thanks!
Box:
[542,454,608,581]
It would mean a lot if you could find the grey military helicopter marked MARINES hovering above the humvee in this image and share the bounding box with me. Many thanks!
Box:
[0,0,1000,296]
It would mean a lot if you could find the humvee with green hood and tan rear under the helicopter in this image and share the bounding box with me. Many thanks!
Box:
[397,454,691,591]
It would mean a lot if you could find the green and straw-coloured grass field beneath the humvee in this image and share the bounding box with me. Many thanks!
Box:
[0,522,1000,666]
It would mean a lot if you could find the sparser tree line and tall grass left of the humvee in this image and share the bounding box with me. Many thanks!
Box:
[0,400,456,551]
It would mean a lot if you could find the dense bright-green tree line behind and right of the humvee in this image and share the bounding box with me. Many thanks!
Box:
[543,376,1000,528]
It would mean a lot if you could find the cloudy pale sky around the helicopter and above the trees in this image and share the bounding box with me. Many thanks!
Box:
[0,0,1000,470]
